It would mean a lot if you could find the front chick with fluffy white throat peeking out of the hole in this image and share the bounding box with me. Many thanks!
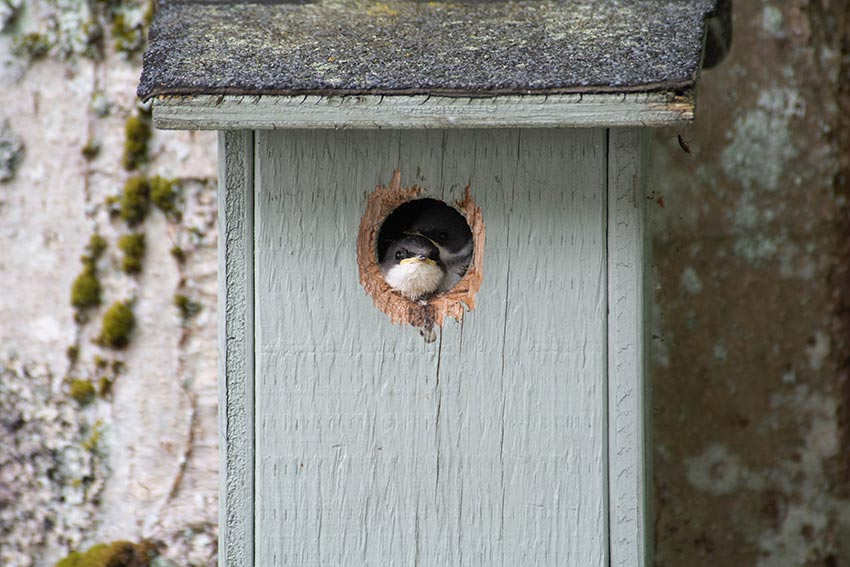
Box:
[380,234,446,302]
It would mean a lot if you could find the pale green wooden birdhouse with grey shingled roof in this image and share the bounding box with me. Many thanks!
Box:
[139,0,723,567]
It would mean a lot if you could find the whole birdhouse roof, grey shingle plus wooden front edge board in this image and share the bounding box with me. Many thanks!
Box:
[138,0,715,130]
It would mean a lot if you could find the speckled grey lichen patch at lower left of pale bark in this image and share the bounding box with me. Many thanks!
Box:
[0,353,106,567]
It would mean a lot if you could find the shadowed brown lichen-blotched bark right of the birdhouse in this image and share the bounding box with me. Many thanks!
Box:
[650,0,850,567]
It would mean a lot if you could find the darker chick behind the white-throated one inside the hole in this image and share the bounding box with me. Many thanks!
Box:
[404,201,473,293]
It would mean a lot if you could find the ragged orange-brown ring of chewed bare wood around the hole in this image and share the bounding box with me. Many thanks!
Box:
[357,170,484,331]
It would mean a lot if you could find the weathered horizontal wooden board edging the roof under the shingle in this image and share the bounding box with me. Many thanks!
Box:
[153,90,696,130]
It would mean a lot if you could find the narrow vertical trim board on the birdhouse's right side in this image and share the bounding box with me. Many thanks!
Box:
[608,129,652,567]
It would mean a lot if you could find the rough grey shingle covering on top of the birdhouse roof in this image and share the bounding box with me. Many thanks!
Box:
[138,0,714,99]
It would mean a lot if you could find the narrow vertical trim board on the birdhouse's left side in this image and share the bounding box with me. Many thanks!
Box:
[218,132,254,567]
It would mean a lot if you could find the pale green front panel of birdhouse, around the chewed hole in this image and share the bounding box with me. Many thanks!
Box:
[255,129,609,567]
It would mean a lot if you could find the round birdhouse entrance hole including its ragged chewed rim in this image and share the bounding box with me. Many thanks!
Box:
[357,171,484,331]
